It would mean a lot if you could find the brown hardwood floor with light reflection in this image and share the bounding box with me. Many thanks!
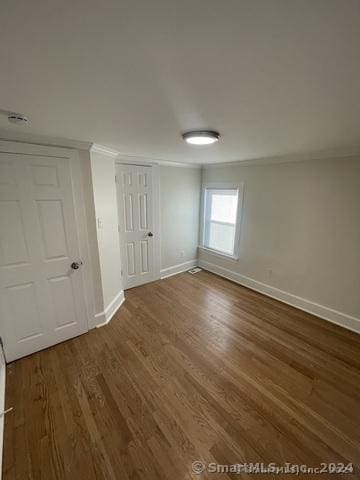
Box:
[4,272,360,480]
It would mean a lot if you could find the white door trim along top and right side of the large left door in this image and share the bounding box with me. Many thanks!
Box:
[0,140,95,329]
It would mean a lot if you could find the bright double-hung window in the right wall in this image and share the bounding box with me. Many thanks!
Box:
[202,185,242,257]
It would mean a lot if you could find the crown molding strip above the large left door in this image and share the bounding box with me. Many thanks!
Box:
[0,129,91,150]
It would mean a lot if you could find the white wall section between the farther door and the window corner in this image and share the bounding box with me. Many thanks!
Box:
[159,166,201,275]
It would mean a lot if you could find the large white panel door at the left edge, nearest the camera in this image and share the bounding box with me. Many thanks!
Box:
[0,153,88,361]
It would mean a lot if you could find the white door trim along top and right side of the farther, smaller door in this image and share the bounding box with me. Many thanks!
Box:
[115,158,161,286]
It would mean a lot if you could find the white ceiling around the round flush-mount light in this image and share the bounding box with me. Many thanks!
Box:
[0,0,360,163]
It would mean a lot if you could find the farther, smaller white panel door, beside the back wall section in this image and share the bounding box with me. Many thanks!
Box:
[116,165,155,288]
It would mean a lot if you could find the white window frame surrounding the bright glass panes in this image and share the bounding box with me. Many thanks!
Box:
[199,182,244,260]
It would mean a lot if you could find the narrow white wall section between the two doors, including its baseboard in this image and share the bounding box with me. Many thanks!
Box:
[90,151,123,323]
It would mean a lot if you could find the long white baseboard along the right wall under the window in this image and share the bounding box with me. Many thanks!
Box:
[198,260,360,333]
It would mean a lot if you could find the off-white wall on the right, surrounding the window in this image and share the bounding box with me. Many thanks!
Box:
[200,158,360,329]
